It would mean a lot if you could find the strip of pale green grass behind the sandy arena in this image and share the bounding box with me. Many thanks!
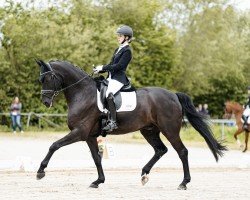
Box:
[0,125,245,149]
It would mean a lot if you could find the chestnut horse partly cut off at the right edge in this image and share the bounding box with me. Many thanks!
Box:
[224,101,250,152]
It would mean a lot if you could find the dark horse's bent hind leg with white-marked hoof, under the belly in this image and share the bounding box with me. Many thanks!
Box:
[140,127,168,185]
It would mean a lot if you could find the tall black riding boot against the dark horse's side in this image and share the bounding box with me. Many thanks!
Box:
[102,93,118,132]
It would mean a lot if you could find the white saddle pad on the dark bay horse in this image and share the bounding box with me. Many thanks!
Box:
[97,90,136,113]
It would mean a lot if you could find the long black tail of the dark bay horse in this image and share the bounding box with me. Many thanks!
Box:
[176,92,227,161]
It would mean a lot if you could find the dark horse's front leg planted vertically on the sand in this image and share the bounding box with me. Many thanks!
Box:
[86,137,105,188]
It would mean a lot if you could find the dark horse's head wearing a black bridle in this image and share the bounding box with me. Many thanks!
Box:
[36,60,62,107]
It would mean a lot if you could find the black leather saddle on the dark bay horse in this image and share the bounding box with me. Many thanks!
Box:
[94,76,136,110]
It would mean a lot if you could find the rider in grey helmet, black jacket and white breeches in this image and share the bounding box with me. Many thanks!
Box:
[93,25,133,132]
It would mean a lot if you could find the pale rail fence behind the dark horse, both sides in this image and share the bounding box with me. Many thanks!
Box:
[0,112,235,139]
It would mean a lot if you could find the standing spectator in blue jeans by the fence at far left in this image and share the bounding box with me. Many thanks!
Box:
[10,97,23,133]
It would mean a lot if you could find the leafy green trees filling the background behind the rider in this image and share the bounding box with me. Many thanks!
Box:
[0,0,250,118]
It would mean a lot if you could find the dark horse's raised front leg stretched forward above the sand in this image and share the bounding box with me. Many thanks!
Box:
[36,129,81,180]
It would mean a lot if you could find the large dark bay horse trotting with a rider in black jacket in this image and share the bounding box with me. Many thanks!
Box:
[36,60,226,190]
